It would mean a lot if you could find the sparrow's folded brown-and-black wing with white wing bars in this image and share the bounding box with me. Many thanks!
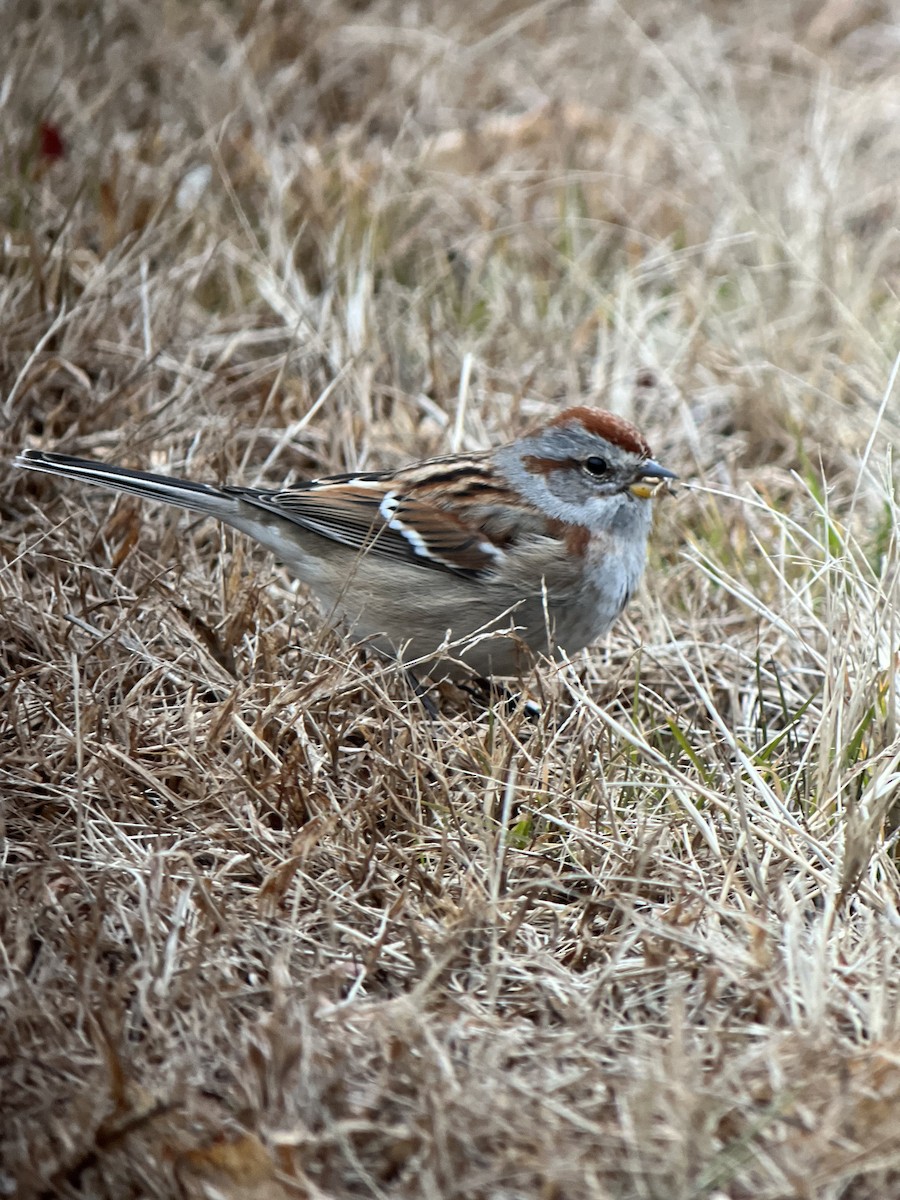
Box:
[222,475,505,578]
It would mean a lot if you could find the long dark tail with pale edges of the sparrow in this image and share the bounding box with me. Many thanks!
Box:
[13,450,247,524]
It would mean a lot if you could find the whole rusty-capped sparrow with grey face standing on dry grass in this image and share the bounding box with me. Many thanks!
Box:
[16,408,677,676]
